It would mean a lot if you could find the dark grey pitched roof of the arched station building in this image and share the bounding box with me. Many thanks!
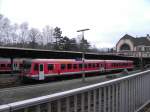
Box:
[122,34,150,46]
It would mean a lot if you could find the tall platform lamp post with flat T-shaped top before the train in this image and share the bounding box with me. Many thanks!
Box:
[77,29,90,82]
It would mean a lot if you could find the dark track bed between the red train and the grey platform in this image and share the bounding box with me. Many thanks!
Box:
[0,70,141,89]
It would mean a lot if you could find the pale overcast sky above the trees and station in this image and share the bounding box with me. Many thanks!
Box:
[0,0,150,48]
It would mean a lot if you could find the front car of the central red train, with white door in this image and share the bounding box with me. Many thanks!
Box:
[22,59,104,80]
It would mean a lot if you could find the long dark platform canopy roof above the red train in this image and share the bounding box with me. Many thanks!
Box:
[0,47,136,60]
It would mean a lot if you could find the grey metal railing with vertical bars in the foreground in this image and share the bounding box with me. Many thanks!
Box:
[0,70,150,112]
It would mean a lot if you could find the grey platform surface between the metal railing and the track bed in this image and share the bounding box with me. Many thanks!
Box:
[0,69,142,105]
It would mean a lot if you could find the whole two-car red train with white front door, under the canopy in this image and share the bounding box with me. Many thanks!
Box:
[22,59,134,80]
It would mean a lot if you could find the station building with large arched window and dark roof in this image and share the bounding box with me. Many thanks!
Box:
[116,34,150,57]
